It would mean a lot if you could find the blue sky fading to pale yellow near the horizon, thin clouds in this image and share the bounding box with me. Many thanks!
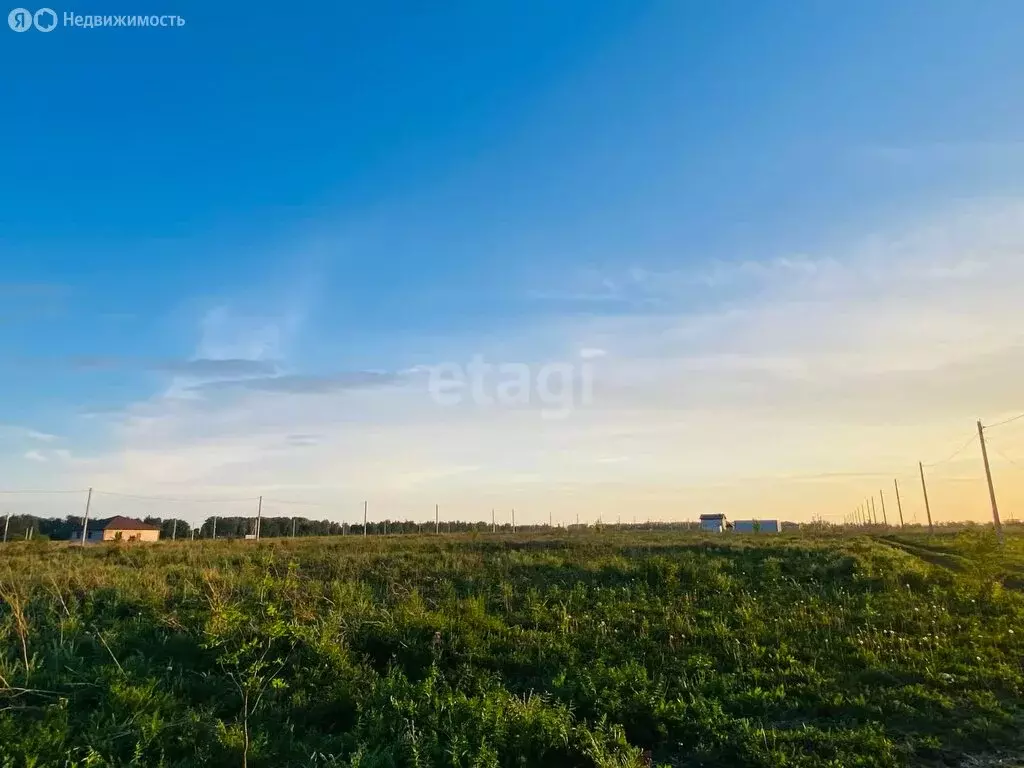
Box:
[0,0,1024,523]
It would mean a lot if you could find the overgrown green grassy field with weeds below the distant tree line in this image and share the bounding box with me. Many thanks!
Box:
[0,532,1024,768]
